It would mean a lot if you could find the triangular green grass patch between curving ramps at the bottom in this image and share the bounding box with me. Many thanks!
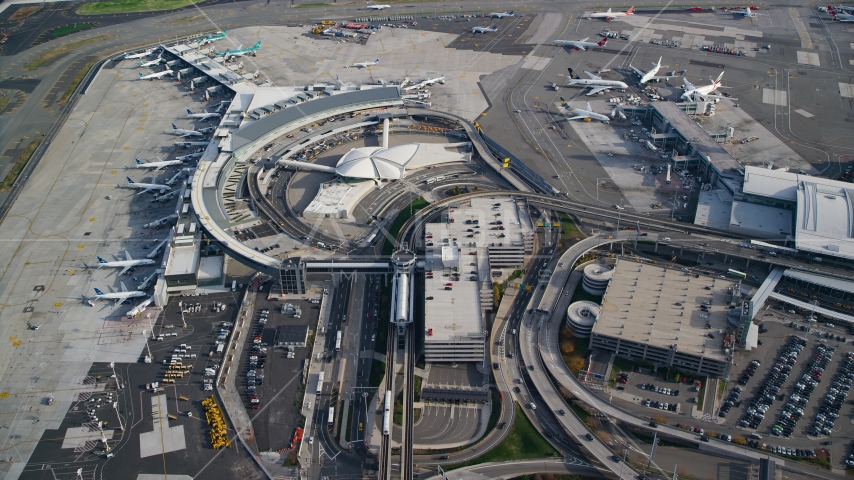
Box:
[446,403,558,470]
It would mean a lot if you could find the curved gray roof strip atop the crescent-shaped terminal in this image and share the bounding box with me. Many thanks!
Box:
[232,87,400,150]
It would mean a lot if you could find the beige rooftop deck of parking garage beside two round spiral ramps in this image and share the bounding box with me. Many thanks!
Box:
[593,258,736,360]
